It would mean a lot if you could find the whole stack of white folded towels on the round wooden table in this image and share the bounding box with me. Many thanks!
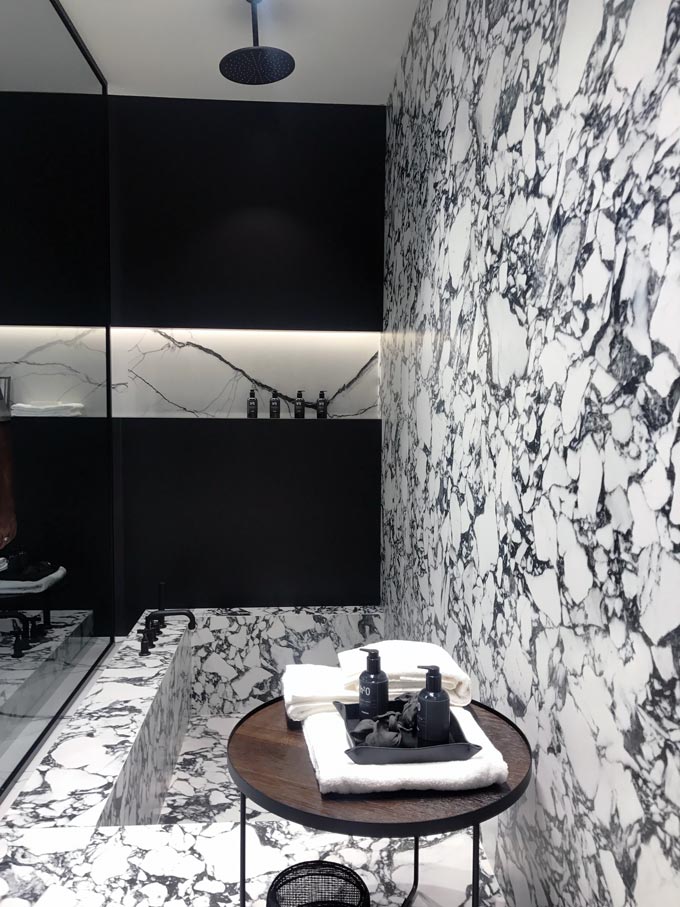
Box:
[283,640,508,794]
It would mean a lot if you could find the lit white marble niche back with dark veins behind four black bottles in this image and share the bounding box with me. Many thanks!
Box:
[112,328,380,419]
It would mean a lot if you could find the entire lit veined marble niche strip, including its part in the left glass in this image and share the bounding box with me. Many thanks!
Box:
[0,325,380,419]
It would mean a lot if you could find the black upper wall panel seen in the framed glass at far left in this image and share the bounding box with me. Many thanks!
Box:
[0,92,109,325]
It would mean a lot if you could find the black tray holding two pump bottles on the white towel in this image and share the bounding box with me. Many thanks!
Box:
[333,700,481,765]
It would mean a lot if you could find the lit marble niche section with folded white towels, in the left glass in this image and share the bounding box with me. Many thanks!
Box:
[0,325,106,416]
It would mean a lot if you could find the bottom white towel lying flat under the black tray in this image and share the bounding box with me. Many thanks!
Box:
[302,706,508,794]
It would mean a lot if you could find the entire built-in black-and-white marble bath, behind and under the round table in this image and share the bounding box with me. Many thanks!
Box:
[0,608,504,907]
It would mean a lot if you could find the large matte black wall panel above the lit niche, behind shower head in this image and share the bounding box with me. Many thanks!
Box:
[110,97,385,331]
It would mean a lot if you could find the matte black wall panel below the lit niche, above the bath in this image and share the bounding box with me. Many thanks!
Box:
[116,419,381,633]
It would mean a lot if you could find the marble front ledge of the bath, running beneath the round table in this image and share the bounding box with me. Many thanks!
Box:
[0,819,505,907]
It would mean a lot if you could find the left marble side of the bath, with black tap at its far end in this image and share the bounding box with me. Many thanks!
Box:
[3,619,190,828]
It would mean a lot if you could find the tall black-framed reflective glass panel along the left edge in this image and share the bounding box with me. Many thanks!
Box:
[0,0,112,793]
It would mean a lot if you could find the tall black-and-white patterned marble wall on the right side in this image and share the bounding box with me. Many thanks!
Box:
[381,0,680,907]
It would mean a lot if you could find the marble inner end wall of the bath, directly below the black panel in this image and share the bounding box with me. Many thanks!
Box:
[192,607,384,715]
